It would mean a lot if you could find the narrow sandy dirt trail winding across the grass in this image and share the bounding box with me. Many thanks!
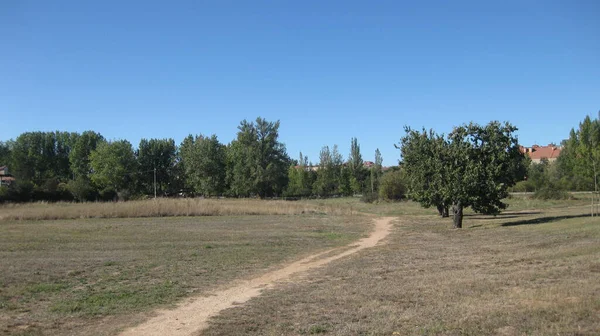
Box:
[121,217,394,336]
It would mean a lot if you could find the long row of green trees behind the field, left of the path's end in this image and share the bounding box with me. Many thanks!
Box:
[0,117,394,202]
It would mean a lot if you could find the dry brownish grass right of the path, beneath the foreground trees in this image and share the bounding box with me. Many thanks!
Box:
[204,204,600,336]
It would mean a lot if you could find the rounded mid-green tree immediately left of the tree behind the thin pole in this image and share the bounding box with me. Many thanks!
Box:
[90,140,138,197]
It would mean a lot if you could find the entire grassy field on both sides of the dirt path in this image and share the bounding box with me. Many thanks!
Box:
[0,198,600,335]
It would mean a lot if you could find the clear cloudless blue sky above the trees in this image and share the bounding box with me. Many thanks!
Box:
[0,0,600,165]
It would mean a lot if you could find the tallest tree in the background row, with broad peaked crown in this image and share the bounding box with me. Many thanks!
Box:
[228,117,290,198]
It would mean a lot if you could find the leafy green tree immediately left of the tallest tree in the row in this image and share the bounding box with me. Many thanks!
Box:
[180,135,226,196]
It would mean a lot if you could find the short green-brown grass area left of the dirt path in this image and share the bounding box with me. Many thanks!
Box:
[0,214,370,335]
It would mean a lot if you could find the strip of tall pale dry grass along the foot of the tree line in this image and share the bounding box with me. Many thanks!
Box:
[0,198,349,220]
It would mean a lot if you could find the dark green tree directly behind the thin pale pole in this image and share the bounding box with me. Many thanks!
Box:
[137,139,177,195]
